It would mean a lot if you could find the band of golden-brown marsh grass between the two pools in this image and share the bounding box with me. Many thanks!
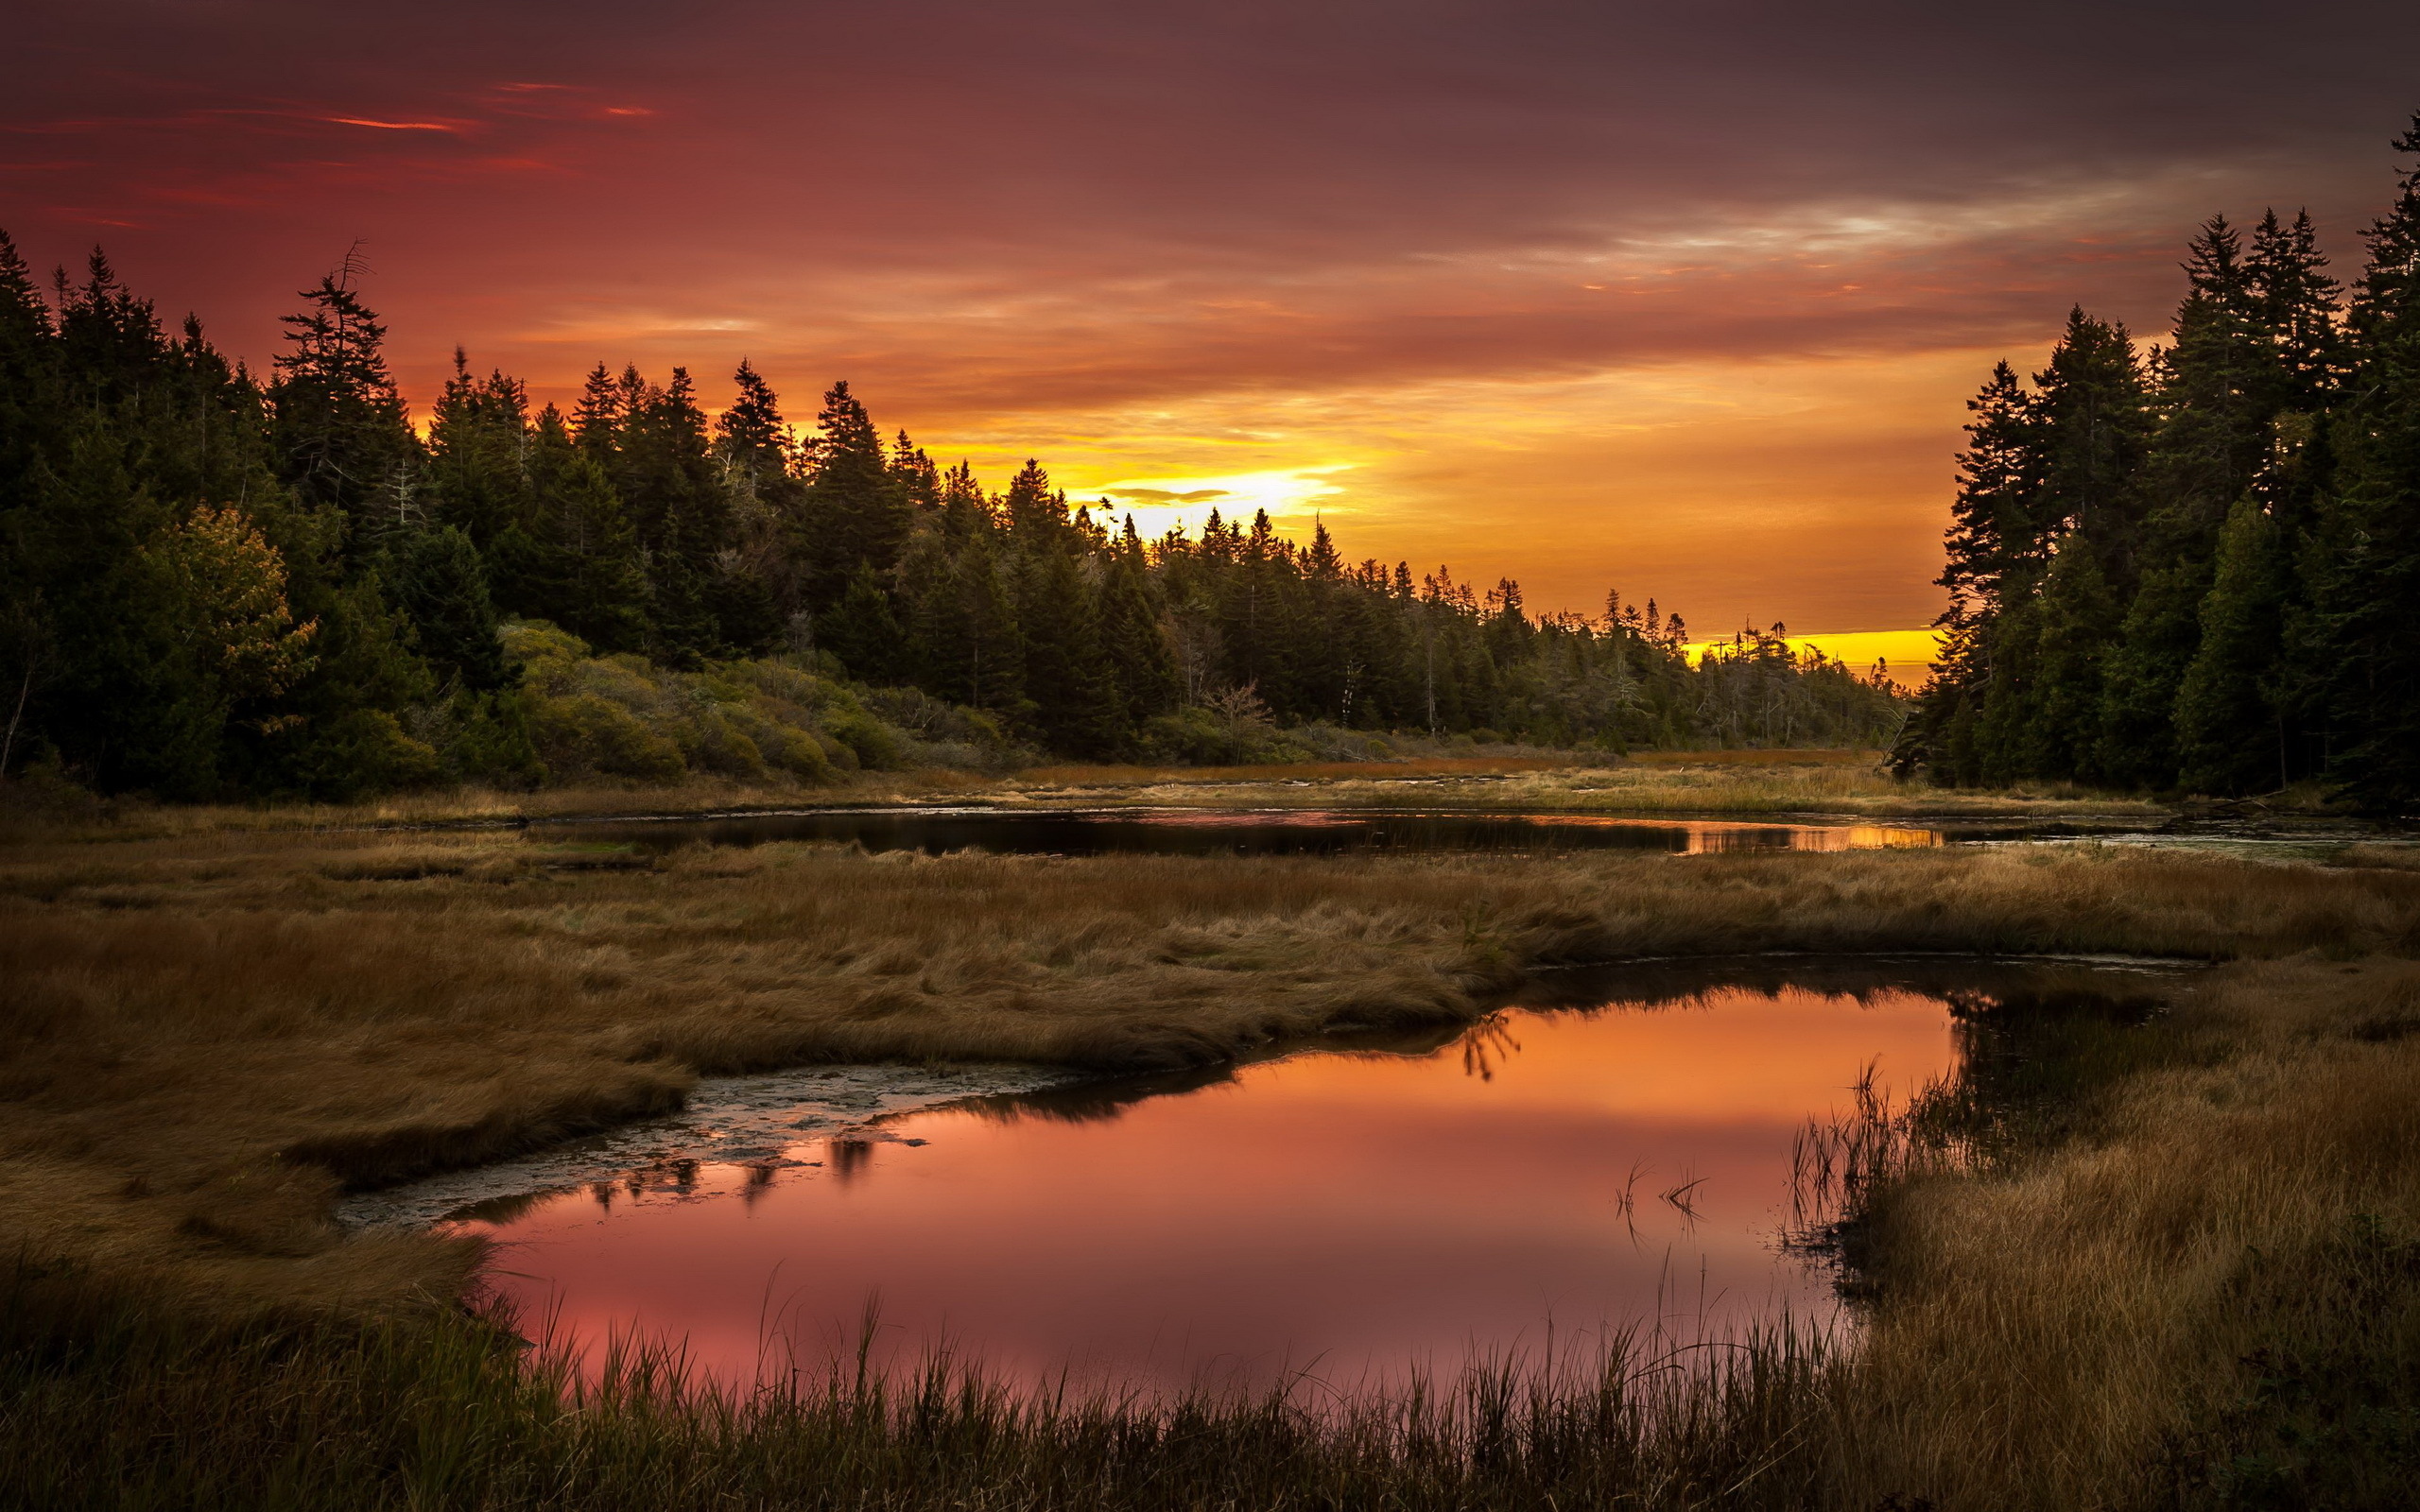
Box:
[0,830,2420,1299]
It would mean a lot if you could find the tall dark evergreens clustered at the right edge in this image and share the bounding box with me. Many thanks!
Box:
[1894,116,2420,811]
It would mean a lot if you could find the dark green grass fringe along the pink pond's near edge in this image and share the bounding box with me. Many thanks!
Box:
[0,1278,1837,1512]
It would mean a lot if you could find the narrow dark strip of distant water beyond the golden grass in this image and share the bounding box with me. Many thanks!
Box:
[544,808,1962,856]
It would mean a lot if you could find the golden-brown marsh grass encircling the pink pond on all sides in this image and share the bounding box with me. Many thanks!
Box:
[0,830,2420,1512]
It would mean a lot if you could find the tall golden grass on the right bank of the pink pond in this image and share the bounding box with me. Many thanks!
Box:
[1840,958,2420,1509]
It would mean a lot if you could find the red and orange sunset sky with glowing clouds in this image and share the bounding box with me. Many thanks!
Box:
[0,0,2420,656]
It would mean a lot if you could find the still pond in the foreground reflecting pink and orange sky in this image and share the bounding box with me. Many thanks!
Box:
[455,960,2147,1386]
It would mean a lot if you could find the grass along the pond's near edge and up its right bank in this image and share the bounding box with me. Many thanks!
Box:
[0,955,2420,1512]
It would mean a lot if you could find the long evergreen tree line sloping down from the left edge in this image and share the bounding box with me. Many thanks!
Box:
[0,237,1900,799]
